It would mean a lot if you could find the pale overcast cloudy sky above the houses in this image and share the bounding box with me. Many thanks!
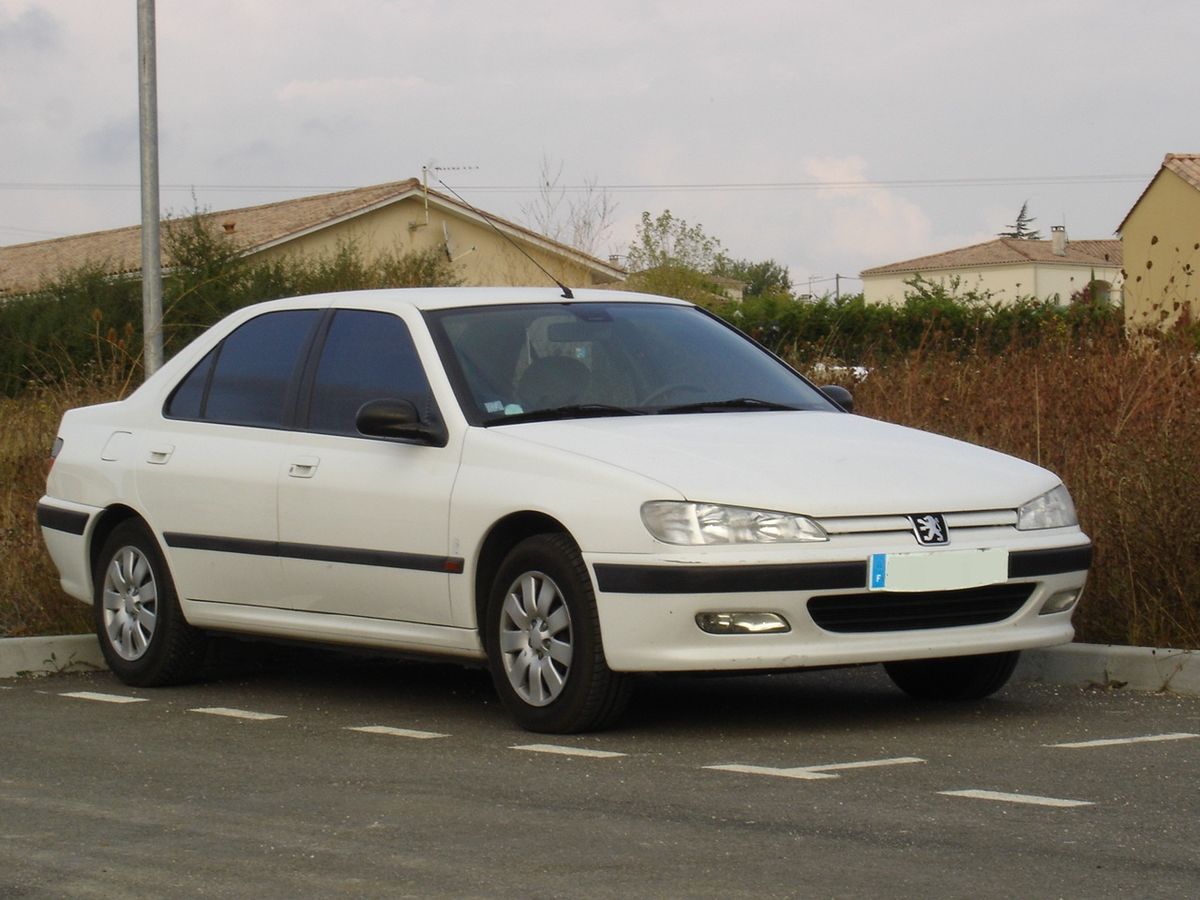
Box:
[0,0,1200,294]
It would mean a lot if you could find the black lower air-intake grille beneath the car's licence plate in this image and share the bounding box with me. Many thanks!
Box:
[809,584,1036,634]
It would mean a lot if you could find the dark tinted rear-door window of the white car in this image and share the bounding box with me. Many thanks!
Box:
[166,310,320,427]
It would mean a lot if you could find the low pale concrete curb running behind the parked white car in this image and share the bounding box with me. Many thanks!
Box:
[0,635,1200,697]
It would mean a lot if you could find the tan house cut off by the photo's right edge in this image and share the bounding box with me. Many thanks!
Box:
[1117,154,1200,329]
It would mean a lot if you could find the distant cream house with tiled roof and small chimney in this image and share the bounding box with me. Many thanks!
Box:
[860,226,1122,305]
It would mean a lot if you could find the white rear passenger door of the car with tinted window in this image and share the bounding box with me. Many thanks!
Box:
[136,310,322,605]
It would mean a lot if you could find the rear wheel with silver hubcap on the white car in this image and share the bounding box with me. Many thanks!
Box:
[92,520,206,686]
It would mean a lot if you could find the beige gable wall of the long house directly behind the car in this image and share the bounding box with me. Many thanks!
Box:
[248,198,614,287]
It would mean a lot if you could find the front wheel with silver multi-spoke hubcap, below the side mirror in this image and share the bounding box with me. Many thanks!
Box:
[484,534,631,734]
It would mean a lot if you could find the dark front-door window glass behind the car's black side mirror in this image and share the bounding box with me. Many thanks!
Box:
[308,310,431,434]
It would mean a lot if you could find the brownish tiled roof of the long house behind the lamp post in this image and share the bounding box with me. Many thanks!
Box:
[0,179,614,295]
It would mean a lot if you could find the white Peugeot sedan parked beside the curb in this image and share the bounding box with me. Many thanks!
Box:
[37,288,1092,732]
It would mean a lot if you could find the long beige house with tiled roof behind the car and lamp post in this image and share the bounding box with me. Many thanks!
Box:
[0,179,625,298]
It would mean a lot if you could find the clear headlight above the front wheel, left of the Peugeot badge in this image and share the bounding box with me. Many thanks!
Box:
[642,500,829,545]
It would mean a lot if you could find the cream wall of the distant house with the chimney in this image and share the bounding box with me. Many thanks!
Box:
[863,263,1121,305]
